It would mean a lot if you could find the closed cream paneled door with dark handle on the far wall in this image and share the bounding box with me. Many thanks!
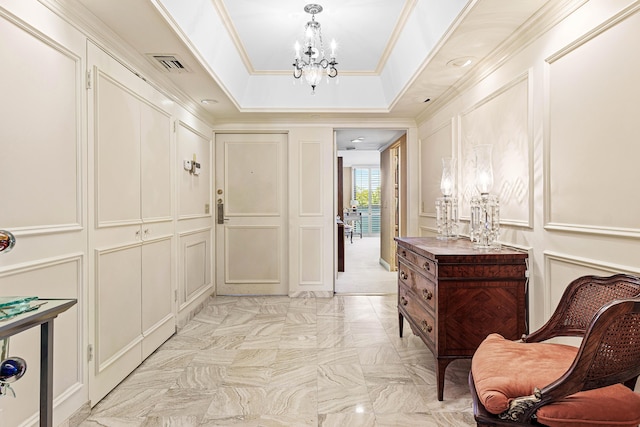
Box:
[214,134,288,295]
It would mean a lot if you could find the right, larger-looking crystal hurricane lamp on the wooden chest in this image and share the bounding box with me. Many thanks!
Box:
[470,145,500,250]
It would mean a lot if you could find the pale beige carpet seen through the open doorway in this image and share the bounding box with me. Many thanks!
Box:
[335,235,398,294]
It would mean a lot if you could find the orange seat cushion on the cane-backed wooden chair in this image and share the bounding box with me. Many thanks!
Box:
[471,334,640,427]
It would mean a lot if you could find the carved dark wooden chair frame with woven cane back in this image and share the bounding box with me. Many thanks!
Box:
[469,274,640,426]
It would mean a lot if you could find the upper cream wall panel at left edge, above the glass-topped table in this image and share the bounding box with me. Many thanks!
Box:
[0,15,83,232]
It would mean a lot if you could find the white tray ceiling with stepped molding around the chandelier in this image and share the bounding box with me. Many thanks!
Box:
[65,0,564,148]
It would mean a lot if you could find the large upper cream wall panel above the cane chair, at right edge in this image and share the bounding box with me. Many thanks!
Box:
[547,12,640,237]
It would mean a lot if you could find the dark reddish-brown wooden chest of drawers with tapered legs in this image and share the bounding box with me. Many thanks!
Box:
[395,237,528,400]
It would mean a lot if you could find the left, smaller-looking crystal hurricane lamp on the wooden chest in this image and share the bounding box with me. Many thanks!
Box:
[436,157,458,240]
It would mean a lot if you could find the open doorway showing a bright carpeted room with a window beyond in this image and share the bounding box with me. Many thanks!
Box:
[335,129,406,294]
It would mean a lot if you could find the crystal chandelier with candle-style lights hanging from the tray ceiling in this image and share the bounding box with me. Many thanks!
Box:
[293,3,338,95]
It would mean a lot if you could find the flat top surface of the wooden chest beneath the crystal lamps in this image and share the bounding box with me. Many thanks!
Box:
[395,237,527,259]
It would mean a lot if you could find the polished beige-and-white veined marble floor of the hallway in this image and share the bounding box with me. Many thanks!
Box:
[81,295,475,427]
